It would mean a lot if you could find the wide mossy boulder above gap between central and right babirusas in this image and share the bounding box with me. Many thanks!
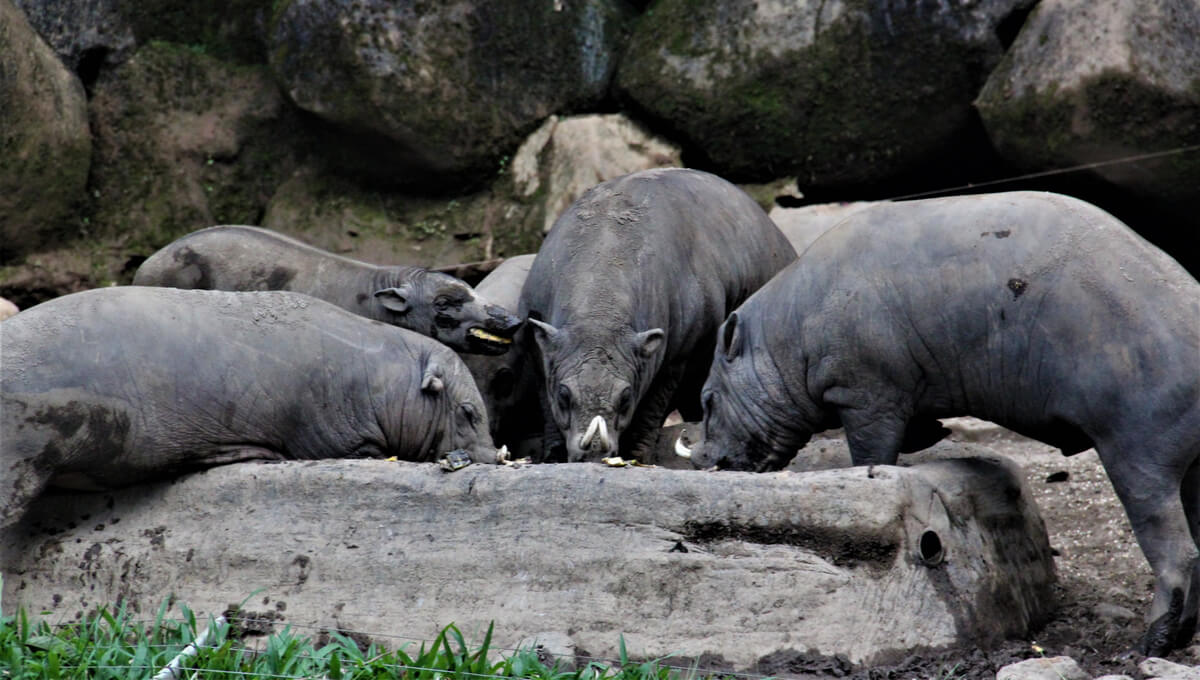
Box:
[617,0,1030,188]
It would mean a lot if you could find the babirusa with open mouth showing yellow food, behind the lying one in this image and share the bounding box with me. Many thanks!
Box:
[133,225,521,354]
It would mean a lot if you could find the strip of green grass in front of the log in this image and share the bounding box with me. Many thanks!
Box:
[0,602,697,680]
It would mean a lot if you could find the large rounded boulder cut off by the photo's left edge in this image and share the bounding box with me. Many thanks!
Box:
[0,0,91,263]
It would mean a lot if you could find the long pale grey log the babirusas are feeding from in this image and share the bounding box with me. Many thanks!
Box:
[0,448,1055,668]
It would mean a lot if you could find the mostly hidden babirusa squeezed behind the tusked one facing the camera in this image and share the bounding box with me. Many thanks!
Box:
[462,254,542,449]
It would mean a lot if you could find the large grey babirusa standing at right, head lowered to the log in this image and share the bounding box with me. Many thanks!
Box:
[691,192,1200,655]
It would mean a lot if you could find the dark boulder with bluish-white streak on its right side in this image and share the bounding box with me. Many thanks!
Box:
[269,0,632,185]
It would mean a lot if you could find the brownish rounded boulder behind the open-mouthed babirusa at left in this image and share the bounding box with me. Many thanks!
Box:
[90,42,304,255]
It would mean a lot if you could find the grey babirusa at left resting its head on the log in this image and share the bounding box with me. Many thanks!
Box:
[0,287,496,526]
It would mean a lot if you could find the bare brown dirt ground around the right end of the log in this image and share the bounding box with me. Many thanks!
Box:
[758,429,1200,680]
